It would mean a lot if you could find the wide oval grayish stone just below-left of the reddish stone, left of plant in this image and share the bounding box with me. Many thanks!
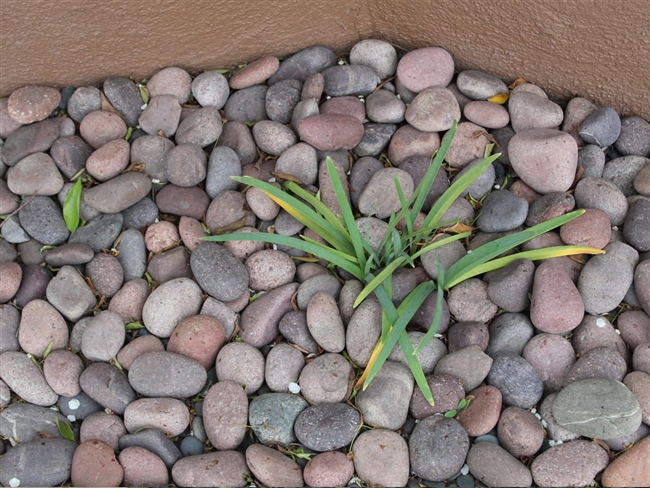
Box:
[129,352,207,398]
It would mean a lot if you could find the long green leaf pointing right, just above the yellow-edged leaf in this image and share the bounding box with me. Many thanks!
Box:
[445,210,585,288]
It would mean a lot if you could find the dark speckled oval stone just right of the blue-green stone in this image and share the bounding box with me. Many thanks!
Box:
[294,403,361,452]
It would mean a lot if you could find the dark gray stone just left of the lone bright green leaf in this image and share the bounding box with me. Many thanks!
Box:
[18,196,70,246]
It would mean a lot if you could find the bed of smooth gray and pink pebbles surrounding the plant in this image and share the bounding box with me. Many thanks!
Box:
[0,40,650,487]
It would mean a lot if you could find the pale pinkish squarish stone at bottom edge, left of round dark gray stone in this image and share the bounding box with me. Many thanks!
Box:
[352,429,409,486]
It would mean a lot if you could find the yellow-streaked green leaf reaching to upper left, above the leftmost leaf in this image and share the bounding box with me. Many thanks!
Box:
[232,176,353,251]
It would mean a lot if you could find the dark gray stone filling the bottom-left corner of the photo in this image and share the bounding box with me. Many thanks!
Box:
[0,439,77,486]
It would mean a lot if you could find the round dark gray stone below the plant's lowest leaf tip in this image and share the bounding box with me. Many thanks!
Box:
[409,415,469,481]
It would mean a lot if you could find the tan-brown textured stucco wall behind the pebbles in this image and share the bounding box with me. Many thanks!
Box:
[0,0,650,119]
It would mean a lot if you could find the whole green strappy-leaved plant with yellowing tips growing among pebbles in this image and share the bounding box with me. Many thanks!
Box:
[202,122,603,405]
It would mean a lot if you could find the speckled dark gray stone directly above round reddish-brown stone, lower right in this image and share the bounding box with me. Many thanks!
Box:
[486,353,544,409]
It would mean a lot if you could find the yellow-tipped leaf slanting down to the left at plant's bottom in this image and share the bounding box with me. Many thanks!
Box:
[363,281,435,390]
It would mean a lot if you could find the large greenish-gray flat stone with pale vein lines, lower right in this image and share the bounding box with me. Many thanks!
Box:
[553,378,642,439]
